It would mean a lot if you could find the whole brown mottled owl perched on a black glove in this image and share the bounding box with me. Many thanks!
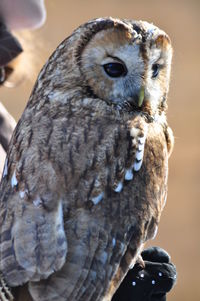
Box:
[0,18,173,301]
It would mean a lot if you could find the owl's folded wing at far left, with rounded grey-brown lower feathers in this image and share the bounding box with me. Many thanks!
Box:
[0,116,67,286]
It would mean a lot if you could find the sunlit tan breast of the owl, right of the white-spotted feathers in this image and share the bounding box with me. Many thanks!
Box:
[121,119,168,240]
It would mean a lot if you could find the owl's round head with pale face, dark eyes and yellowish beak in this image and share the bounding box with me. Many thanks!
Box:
[36,18,172,114]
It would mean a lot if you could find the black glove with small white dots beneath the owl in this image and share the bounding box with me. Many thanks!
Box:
[112,247,176,301]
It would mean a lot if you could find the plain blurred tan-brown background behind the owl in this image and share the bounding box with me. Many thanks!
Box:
[0,0,200,301]
